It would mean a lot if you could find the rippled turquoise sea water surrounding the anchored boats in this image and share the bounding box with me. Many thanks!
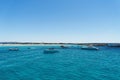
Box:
[0,46,120,80]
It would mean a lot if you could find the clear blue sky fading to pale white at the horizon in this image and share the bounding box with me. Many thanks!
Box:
[0,0,120,42]
